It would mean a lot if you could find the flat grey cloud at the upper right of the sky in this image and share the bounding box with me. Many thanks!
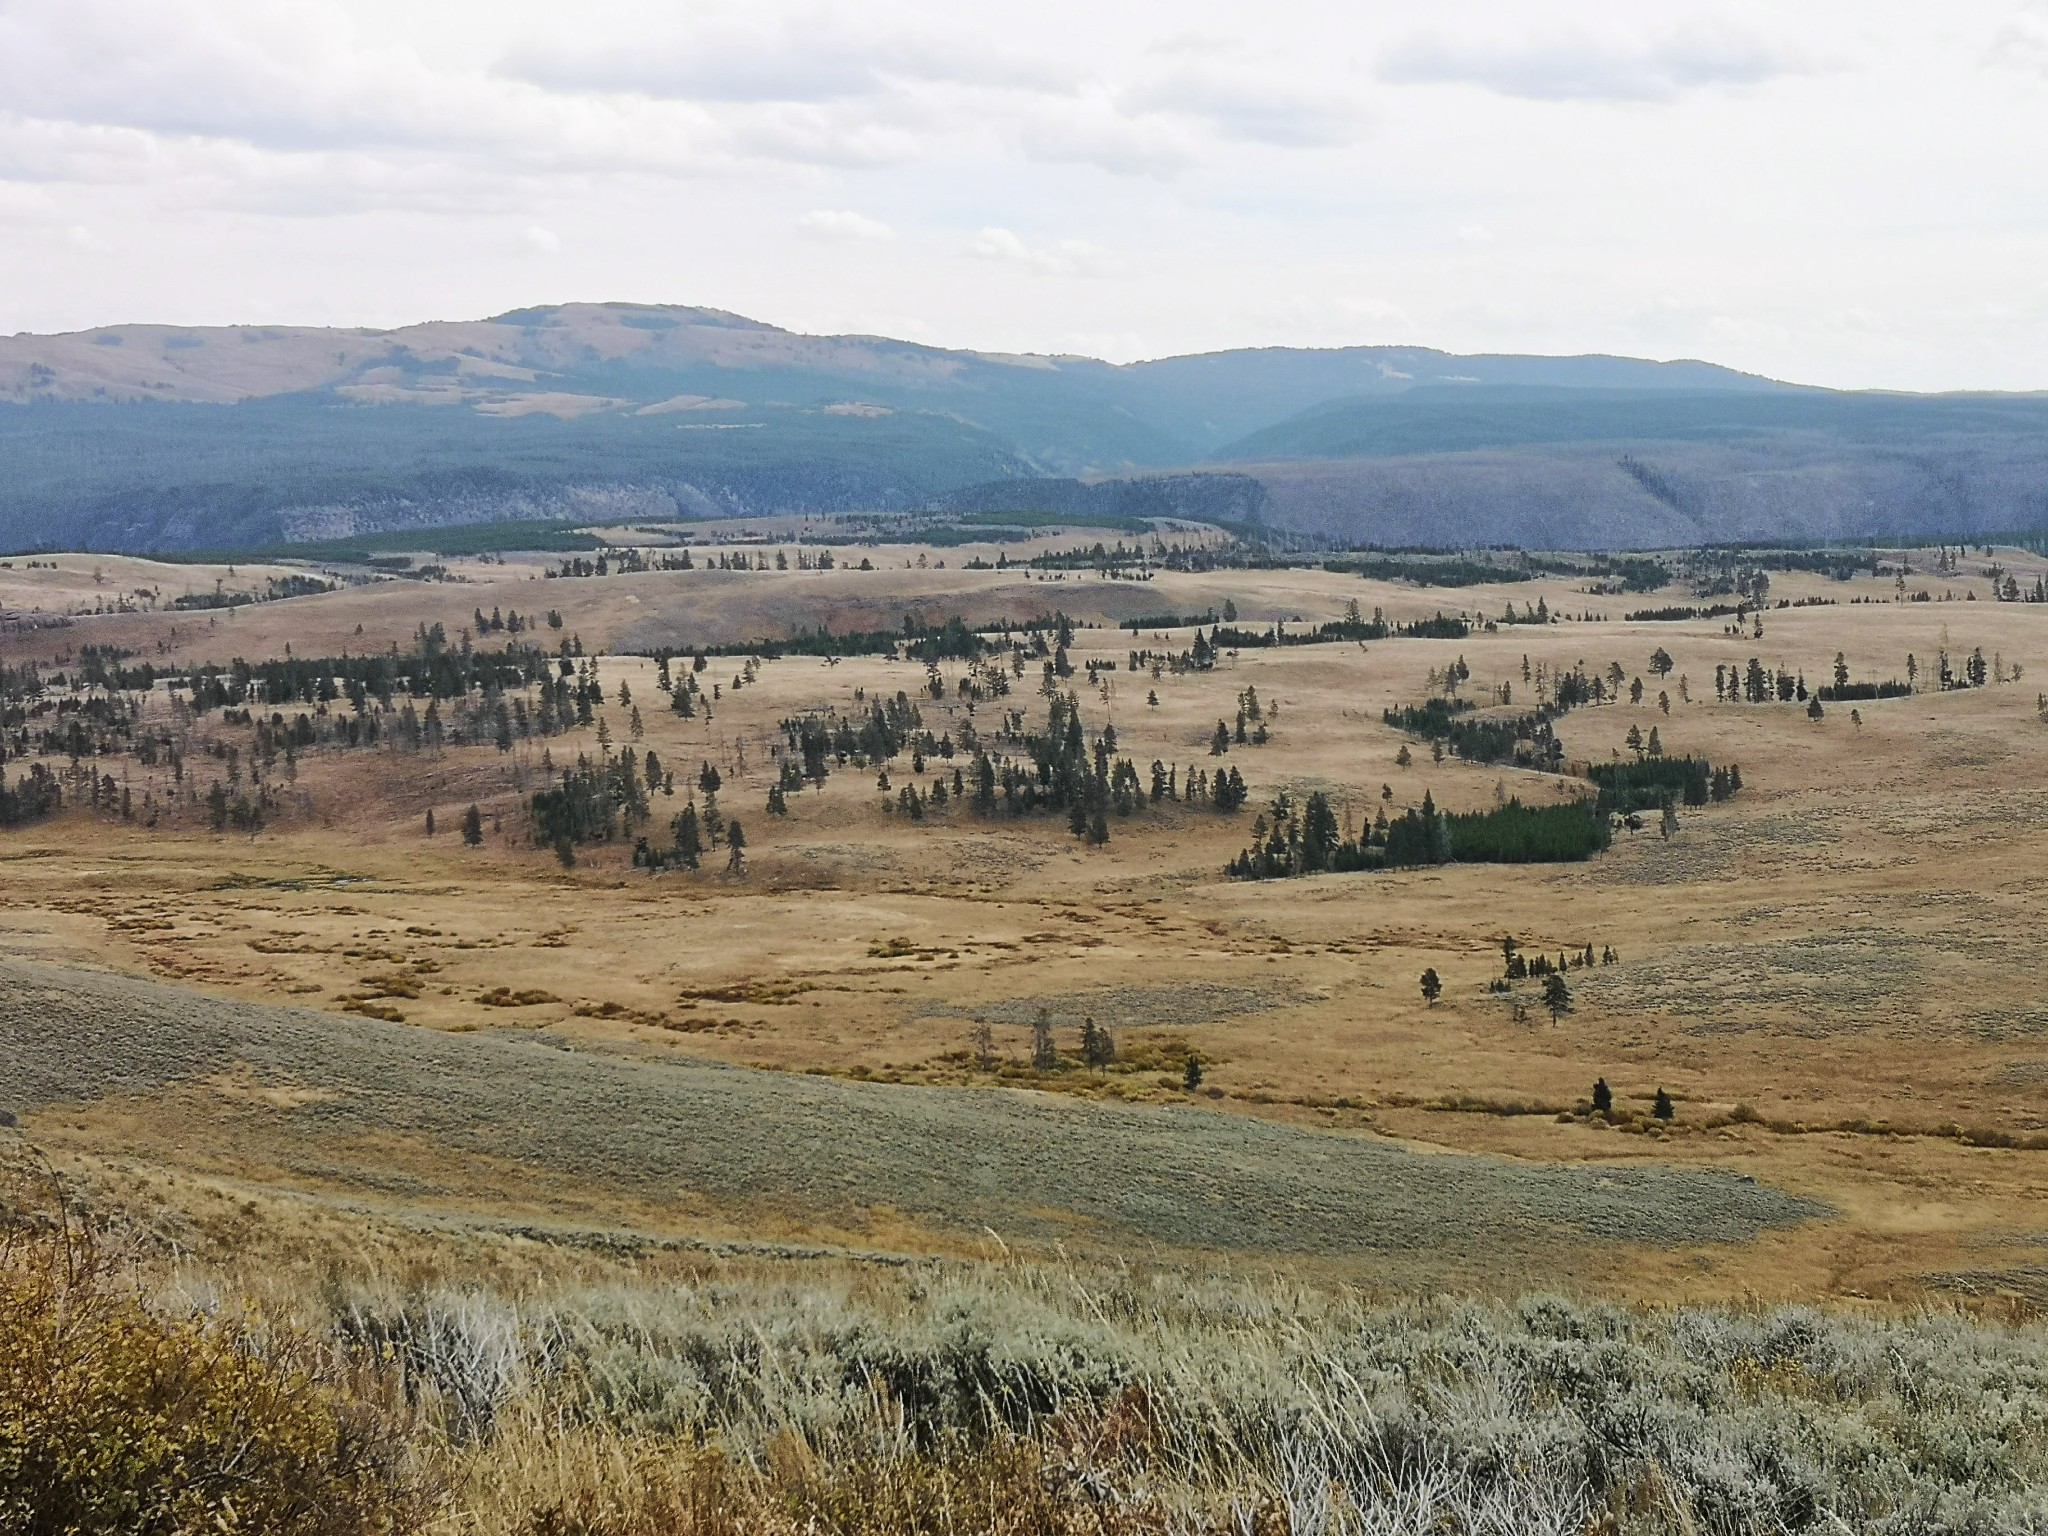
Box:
[1378,27,1810,100]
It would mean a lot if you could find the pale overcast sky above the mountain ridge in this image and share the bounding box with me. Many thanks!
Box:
[0,0,2048,389]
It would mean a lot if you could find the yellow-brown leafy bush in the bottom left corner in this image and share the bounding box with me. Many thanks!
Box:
[0,1229,426,1536]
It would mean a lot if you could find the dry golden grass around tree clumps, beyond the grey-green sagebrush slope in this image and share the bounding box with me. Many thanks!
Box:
[0,551,2048,1296]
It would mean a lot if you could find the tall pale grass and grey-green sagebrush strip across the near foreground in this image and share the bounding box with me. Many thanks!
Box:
[0,1212,2048,1536]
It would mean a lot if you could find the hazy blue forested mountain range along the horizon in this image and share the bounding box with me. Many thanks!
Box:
[0,303,2048,551]
